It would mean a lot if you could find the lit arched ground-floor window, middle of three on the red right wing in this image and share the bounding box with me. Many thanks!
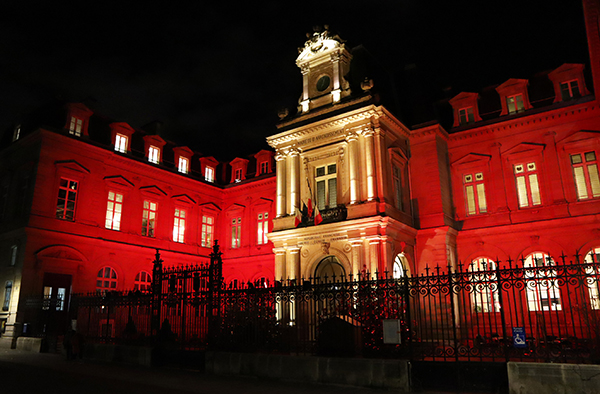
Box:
[523,252,562,311]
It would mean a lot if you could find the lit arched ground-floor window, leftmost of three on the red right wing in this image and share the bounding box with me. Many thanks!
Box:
[468,257,500,312]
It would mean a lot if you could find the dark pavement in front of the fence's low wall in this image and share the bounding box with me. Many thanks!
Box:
[0,349,478,394]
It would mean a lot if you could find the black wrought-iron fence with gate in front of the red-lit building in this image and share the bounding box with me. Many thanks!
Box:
[69,246,600,362]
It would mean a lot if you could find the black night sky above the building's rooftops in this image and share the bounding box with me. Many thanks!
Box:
[0,0,588,159]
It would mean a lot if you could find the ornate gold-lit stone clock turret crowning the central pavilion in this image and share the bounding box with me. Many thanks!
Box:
[296,26,352,113]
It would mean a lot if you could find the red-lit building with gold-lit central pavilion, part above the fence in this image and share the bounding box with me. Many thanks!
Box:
[0,1,600,350]
